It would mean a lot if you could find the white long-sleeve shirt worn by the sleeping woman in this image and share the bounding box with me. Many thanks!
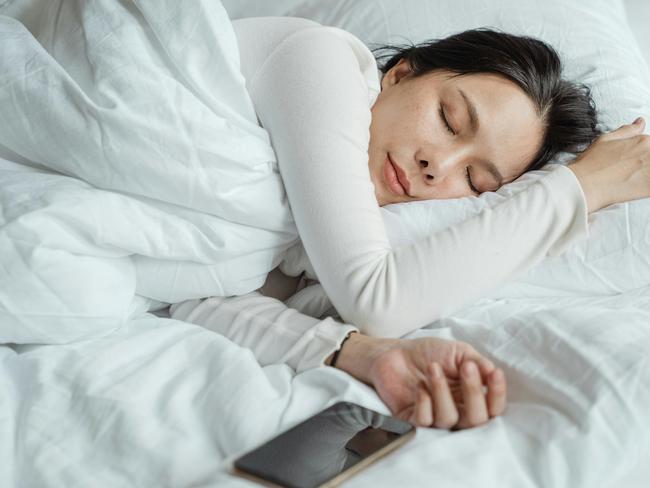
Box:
[172,18,588,371]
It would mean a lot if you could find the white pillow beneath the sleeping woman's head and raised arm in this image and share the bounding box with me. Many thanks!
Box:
[223,0,650,297]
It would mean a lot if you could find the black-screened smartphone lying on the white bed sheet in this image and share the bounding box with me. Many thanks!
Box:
[233,402,415,488]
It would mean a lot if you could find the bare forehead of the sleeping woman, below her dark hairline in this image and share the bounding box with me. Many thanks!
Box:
[434,72,543,181]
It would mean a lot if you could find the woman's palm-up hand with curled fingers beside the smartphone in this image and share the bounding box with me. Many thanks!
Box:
[336,333,506,429]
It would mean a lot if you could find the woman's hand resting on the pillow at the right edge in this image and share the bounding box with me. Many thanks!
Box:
[568,118,650,212]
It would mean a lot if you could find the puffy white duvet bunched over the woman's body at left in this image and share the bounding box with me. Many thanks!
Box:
[0,1,297,343]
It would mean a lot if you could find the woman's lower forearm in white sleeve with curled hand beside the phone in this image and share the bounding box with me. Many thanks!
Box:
[170,292,506,428]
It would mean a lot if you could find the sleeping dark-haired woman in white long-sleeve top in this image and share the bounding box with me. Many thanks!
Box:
[171,18,650,429]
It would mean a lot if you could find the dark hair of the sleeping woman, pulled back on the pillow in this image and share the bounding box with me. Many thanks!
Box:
[373,28,601,171]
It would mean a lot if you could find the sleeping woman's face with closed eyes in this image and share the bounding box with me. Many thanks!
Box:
[368,60,543,205]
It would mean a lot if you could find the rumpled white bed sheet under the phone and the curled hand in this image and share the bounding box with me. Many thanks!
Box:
[0,290,650,488]
